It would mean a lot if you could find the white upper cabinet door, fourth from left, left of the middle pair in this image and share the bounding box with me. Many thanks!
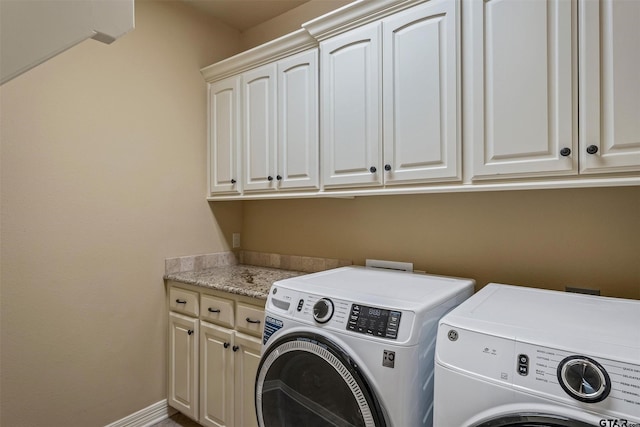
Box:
[320,23,382,187]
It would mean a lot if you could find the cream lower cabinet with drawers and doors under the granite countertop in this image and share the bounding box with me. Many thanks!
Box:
[169,284,264,427]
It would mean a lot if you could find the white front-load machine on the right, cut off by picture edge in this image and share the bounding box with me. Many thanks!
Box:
[434,284,640,427]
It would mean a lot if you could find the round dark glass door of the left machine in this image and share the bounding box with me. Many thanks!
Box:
[256,334,386,427]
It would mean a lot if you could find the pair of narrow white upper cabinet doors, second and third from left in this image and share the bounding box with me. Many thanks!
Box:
[242,49,318,191]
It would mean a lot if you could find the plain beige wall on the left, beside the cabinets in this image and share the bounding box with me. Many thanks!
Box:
[0,1,242,427]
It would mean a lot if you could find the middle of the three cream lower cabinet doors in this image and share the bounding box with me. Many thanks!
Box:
[200,321,235,427]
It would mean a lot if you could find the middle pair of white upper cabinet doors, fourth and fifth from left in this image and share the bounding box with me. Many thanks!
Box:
[320,0,460,187]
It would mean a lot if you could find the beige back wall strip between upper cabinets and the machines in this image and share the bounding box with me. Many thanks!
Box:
[242,187,640,299]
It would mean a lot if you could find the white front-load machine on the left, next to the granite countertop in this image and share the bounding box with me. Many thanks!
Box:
[256,267,474,427]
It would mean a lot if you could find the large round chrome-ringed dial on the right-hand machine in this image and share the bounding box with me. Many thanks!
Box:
[558,356,611,403]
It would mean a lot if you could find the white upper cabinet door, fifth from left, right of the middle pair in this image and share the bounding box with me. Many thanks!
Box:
[383,0,460,184]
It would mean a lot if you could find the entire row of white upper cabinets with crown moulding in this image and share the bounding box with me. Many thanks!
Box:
[202,0,640,200]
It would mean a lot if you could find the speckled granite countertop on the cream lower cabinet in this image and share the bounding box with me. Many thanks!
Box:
[164,265,307,300]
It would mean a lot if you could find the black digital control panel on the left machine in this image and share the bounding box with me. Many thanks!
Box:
[347,304,402,339]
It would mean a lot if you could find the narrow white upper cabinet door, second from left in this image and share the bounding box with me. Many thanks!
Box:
[242,64,278,191]
